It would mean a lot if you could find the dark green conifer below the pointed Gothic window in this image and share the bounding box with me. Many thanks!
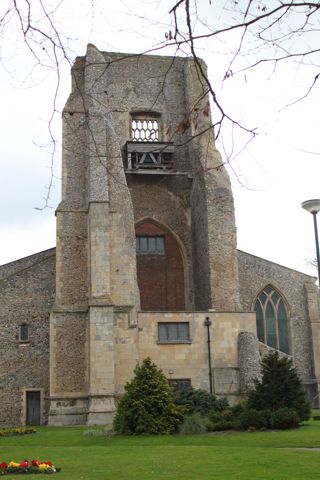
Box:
[247,351,310,421]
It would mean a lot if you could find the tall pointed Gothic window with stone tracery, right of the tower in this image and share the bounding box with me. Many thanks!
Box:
[254,285,289,353]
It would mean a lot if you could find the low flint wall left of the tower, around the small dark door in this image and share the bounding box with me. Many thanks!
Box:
[0,249,55,426]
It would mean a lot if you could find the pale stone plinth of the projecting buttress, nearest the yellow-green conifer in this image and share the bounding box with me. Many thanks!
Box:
[86,395,116,425]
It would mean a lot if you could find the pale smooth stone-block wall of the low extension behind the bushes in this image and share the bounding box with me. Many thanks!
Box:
[138,312,255,401]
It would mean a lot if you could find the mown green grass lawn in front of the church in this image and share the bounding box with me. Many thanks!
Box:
[0,420,320,480]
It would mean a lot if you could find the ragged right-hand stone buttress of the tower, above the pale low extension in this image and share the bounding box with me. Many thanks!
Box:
[185,62,241,311]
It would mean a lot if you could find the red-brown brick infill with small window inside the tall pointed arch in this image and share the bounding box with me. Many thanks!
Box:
[135,218,185,311]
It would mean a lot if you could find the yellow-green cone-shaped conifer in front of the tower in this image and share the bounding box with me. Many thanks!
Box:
[113,358,185,435]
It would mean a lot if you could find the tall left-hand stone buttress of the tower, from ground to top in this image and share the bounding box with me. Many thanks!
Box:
[49,47,139,425]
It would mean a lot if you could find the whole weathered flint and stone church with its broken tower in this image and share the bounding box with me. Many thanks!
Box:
[0,45,320,425]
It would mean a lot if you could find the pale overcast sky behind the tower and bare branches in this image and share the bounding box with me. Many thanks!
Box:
[0,0,320,275]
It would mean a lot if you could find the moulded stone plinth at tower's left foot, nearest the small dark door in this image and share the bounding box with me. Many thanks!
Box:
[48,397,88,426]
